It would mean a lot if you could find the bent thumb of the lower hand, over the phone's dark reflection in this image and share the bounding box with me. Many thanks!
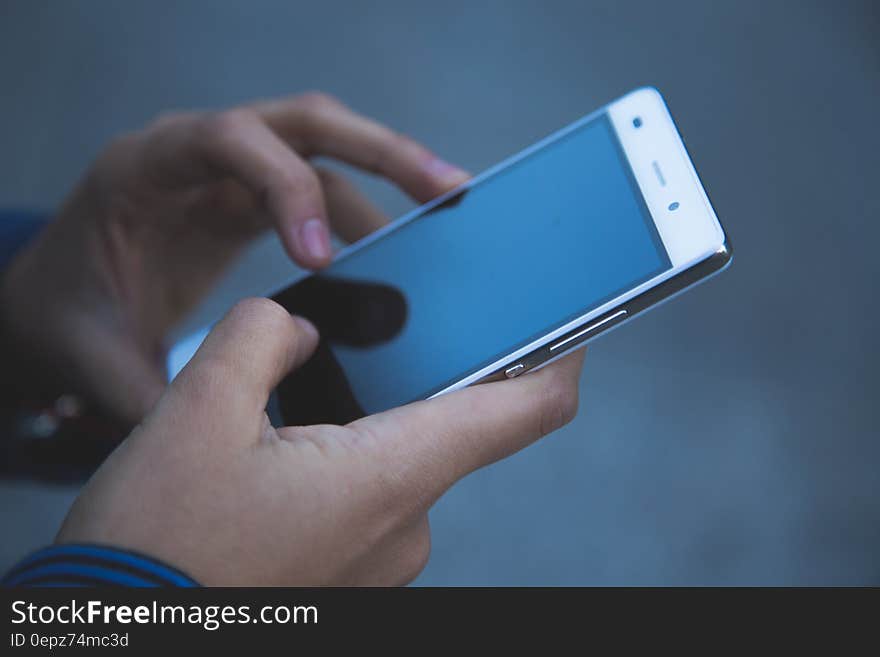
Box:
[171,298,318,421]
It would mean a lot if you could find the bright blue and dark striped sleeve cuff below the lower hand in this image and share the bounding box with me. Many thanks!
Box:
[0,544,198,587]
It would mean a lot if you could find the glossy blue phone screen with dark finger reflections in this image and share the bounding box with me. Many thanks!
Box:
[275,113,671,424]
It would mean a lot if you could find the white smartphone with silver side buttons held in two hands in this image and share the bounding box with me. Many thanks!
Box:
[168,88,731,424]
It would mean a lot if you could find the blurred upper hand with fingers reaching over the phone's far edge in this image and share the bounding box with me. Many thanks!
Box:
[0,93,467,425]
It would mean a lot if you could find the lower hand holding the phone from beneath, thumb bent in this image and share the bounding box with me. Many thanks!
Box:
[57,299,583,586]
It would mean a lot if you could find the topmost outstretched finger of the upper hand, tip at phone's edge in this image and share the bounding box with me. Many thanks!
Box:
[254,93,470,202]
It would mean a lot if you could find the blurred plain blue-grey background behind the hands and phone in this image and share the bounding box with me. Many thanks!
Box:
[0,0,880,585]
